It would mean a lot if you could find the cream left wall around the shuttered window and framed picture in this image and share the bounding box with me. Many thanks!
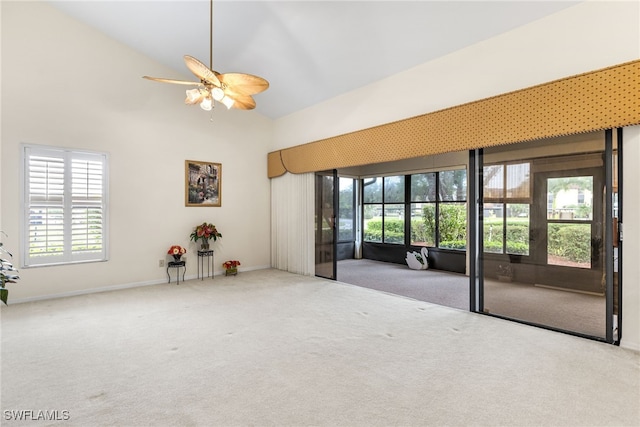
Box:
[0,1,272,302]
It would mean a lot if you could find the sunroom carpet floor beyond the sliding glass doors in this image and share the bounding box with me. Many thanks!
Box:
[337,259,606,338]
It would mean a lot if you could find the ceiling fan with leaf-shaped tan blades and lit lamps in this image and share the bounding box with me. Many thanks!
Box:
[143,0,269,111]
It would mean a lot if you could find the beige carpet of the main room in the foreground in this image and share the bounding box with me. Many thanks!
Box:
[1,270,640,426]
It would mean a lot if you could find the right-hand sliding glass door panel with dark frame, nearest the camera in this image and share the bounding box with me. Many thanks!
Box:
[478,132,617,341]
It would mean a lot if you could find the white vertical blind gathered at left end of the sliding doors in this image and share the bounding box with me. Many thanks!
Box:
[271,173,315,276]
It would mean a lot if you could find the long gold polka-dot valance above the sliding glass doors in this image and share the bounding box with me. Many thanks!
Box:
[268,60,640,178]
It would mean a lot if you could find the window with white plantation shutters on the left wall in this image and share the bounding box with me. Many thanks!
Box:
[22,145,108,267]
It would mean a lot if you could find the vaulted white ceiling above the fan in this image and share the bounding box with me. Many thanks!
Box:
[49,0,579,119]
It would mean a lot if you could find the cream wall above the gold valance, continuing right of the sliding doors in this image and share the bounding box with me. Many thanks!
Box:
[271,1,640,350]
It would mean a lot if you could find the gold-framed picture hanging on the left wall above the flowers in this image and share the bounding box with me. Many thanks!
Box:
[184,160,222,207]
